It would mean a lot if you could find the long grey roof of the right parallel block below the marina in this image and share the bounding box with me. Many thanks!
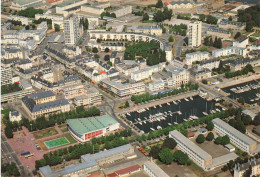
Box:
[212,118,256,145]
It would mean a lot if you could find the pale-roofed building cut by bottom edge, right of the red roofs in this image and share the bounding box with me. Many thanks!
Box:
[143,161,170,177]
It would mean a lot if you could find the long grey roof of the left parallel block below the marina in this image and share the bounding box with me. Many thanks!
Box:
[170,130,212,160]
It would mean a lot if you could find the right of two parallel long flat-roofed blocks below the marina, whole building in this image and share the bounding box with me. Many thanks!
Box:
[212,118,257,154]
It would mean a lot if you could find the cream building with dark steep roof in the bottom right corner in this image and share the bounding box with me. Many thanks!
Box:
[234,158,260,177]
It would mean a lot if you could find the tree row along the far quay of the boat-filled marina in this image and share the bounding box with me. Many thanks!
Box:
[131,82,199,104]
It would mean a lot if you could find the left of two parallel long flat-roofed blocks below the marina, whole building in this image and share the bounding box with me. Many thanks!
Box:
[169,130,212,170]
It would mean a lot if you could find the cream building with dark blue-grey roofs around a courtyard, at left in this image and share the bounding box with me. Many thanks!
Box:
[22,91,70,119]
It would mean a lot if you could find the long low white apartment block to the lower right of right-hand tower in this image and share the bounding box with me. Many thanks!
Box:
[212,46,247,57]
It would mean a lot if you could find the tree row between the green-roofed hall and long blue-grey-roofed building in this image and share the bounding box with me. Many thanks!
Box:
[35,129,132,170]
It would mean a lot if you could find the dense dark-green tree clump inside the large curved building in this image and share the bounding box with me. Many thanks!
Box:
[124,40,166,66]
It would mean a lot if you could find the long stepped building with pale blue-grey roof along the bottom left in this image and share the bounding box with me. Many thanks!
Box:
[39,144,135,177]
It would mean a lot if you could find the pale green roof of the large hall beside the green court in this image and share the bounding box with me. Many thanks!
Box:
[67,115,117,135]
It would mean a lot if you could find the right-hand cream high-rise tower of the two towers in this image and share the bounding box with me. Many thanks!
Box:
[188,21,202,47]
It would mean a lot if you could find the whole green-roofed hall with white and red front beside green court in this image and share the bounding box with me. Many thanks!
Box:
[67,115,120,142]
